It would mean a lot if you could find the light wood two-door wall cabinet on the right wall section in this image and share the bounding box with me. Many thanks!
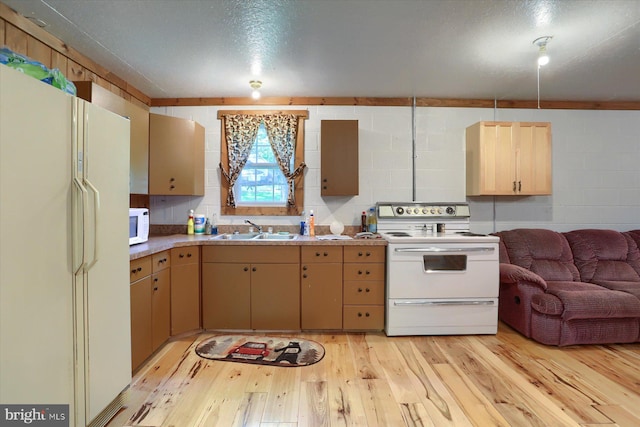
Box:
[466,118,551,196]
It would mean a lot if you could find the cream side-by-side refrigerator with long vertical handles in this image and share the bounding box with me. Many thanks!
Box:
[0,65,131,426]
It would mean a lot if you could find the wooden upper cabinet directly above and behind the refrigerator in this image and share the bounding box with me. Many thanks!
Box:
[74,81,149,194]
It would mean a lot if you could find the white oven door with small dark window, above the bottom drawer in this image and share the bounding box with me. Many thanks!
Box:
[387,243,499,299]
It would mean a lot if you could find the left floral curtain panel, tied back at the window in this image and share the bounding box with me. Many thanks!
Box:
[220,114,262,207]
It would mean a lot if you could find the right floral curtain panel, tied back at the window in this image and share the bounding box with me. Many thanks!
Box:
[262,114,306,206]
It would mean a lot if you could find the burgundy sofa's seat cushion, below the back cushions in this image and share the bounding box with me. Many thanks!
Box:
[546,281,640,320]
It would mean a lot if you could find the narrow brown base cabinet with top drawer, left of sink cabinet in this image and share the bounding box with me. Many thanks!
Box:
[171,246,201,335]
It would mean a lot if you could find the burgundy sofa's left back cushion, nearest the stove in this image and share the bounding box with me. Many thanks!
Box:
[495,228,580,281]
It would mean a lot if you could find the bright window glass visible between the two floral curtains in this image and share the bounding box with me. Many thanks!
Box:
[234,123,294,207]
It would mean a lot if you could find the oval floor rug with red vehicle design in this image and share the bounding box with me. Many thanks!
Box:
[196,335,324,367]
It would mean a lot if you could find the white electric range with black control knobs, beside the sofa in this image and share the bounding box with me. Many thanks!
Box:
[376,202,499,336]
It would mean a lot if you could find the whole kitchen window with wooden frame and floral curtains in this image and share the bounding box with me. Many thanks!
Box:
[218,110,309,216]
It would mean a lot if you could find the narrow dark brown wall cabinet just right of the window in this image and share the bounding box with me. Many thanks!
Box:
[320,120,359,196]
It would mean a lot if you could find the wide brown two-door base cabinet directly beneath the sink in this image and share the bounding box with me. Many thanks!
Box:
[202,245,300,330]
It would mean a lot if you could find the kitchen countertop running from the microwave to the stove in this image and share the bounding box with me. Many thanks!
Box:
[129,234,387,260]
